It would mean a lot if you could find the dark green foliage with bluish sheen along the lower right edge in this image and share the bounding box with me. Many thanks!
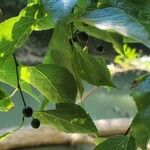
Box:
[131,74,150,150]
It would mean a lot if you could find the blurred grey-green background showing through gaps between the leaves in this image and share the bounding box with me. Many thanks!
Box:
[0,0,150,150]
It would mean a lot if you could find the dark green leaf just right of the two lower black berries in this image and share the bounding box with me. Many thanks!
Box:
[34,103,97,134]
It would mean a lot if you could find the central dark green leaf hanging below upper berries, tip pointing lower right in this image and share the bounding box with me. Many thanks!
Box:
[74,44,114,86]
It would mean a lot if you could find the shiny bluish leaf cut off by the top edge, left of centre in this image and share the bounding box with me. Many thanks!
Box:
[42,0,77,23]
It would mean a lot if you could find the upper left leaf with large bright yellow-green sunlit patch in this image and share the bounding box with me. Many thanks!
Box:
[0,5,39,68]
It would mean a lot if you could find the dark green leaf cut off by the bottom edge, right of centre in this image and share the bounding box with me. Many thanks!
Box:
[94,135,136,150]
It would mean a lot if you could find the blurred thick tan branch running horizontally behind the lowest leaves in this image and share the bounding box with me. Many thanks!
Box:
[0,118,132,150]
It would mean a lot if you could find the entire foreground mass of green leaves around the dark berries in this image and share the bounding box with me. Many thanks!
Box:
[0,0,150,150]
